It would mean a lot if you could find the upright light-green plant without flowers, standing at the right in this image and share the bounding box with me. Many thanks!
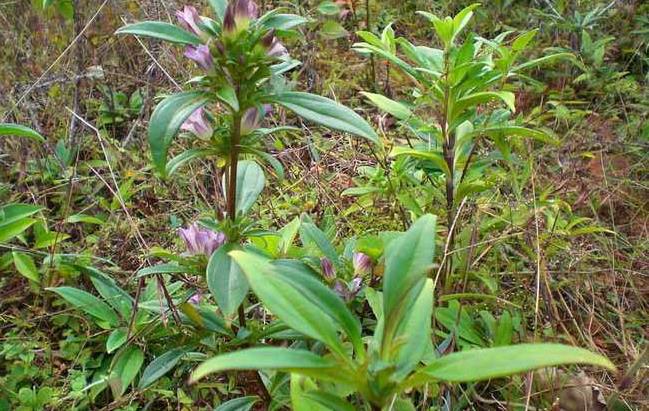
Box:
[354,4,572,292]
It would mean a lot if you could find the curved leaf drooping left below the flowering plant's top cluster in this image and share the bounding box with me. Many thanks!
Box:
[149,91,209,176]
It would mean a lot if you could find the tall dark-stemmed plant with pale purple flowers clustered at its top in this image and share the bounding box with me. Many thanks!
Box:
[117,0,378,327]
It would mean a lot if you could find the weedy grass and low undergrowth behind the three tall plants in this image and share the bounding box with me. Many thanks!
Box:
[0,0,649,411]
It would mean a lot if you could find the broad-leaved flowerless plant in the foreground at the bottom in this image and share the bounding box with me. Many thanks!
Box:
[191,215,613,410]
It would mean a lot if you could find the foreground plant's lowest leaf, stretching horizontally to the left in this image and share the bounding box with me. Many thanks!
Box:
[190,347,336,382]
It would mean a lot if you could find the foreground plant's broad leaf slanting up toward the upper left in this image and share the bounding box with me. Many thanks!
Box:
[230,251,345,354]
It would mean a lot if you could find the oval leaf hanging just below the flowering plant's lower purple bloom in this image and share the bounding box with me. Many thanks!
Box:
[207,244,250,317]
